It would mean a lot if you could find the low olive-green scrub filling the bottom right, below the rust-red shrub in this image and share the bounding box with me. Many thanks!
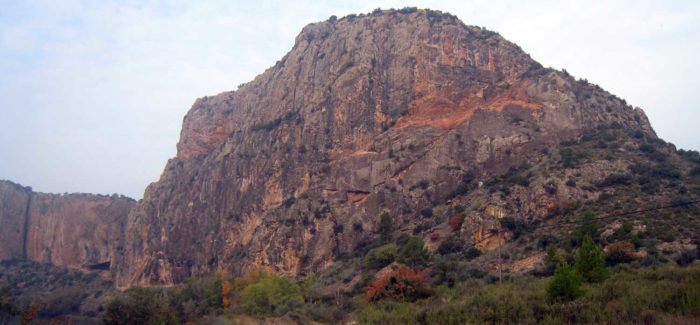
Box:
[359,265,700,324]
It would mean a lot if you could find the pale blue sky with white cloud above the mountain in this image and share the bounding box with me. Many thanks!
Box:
[0,0,700,199]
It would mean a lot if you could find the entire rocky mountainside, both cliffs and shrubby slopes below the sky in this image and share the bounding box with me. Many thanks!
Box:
[0,8,700,324]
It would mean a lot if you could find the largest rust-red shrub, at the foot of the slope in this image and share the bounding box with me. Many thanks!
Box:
[367,266,431,301]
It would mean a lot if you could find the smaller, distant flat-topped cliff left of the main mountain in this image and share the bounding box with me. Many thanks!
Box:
[0,181,136,269]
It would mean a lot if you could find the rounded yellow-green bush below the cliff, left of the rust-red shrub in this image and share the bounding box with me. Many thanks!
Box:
[241,277,304,316]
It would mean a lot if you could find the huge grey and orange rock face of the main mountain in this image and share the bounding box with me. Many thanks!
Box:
[115,10,653,287]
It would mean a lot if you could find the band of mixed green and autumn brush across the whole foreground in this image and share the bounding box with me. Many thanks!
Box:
[95,264,700,324]
